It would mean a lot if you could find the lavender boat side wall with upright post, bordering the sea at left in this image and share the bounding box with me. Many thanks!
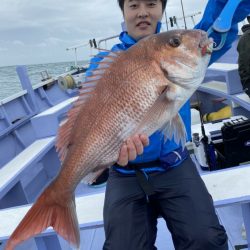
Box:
[0,65,80,144]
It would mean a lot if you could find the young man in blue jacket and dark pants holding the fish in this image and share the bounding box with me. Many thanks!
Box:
[87,0,250,250]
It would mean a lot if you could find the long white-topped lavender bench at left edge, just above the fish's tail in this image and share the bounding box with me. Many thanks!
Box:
[0,136,55,208]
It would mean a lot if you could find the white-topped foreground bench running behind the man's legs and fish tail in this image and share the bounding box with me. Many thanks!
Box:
[0,165,250,250]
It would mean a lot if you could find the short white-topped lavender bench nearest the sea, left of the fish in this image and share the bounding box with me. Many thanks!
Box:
[31,97,78,138]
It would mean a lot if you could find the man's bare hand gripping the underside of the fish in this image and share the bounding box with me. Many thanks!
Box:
[117,134,149,166]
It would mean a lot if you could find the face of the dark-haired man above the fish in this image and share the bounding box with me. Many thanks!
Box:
[123,0,162,40]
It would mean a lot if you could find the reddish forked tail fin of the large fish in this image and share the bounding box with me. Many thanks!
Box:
[5,182,80,250]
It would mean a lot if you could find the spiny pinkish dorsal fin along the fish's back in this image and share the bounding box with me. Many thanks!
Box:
[56,52,119,162]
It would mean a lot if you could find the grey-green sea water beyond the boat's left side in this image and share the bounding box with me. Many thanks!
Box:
[0,61,87,100]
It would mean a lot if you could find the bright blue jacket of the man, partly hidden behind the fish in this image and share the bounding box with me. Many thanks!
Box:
[86,7,240,173]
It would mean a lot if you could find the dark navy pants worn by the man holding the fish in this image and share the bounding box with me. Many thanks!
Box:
[103,158,228,250]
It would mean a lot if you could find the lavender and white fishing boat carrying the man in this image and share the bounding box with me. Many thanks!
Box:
[0,8,250,250]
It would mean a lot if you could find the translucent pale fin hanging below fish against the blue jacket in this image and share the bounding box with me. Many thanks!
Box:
[161,113,187,148]
